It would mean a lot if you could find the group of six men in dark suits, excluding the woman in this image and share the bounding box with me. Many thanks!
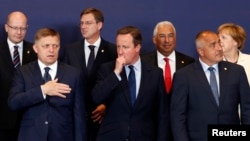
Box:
[0,8,250,141]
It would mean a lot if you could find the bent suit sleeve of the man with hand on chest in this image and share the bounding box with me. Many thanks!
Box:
[8,68,44,110]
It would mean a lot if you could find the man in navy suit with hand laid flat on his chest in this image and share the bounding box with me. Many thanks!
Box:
[8,28,87,141]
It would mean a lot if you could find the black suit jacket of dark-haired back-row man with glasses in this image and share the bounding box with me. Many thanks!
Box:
[63,38,117,115]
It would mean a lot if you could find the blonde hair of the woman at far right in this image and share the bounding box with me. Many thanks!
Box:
[218,23,247,50]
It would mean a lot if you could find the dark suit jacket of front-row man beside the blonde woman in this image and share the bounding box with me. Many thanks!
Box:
[170,61,250,141]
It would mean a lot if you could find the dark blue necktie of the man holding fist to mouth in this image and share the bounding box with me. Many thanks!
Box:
[128,65,136,106]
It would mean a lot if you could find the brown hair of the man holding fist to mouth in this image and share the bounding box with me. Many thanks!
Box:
[116,26,142,46]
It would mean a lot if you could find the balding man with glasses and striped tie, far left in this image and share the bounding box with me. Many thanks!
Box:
[0,11,37,141]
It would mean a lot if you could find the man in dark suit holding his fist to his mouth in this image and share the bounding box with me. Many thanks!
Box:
[92,26,169,141]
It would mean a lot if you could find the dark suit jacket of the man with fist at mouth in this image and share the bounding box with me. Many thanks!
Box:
[92,62,169,141]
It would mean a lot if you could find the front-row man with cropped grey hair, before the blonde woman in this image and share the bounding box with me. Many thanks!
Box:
[170,31,250,141]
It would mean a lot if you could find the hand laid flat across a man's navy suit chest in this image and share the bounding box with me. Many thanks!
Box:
[41,78,71,98]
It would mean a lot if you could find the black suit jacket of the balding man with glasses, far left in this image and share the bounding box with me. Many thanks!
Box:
[0,40,37,129]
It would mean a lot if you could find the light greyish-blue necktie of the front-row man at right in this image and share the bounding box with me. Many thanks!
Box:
[208,67,219,106]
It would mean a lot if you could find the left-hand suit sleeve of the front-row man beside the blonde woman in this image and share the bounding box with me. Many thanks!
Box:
[170,72,188,141]
